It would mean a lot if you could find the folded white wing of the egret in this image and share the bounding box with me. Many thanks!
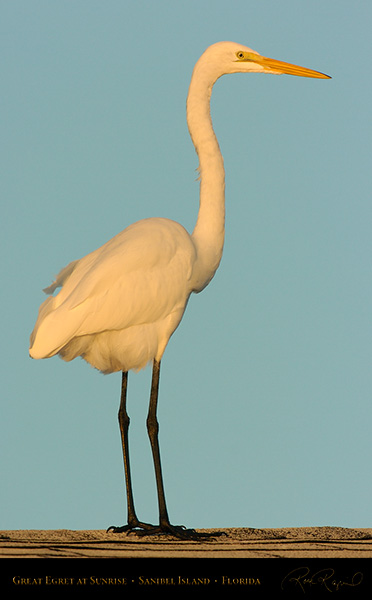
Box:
[31,219,195,357]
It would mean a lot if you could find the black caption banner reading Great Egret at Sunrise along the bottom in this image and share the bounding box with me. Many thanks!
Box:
[0,558,372,600]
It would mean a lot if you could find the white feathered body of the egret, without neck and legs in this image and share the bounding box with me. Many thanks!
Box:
[32,219,196,373]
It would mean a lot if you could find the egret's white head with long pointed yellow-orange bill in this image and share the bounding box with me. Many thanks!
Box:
[197,42,330,79]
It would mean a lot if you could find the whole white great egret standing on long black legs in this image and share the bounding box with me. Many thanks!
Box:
[30,42,328,539]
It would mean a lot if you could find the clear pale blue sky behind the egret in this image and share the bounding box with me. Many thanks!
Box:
[0,0,372,529]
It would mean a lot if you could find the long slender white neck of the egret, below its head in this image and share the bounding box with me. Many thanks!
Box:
[187,63,225,291]
